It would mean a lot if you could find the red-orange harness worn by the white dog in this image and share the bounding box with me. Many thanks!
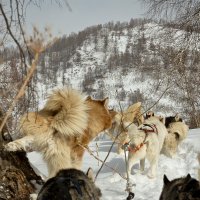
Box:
[123,124,158,153]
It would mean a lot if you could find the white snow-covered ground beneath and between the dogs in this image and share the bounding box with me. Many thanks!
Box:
[28,129,200,200]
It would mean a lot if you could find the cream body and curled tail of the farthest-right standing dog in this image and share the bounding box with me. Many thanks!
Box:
[162,122,189,157]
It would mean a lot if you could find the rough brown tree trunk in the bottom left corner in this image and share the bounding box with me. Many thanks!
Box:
[0,121,43,200]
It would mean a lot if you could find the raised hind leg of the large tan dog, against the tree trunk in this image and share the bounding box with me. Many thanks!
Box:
[4,135,33,152]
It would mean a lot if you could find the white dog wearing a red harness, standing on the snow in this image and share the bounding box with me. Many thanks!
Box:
[127,116,167,178]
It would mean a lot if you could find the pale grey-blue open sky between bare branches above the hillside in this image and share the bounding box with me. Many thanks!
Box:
[25,0,147,36]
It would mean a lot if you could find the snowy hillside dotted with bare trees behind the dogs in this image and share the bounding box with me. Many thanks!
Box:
[0,19,200,130]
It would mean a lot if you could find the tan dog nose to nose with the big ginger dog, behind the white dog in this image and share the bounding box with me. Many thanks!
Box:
[106,102,144,154]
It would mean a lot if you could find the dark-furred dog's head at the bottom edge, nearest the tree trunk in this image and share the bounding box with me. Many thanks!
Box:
[37,168,101,200]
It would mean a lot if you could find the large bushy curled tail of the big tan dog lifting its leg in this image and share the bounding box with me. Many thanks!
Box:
[40,88,89,136]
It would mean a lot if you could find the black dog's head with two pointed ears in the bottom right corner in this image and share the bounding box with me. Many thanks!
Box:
[160,174,200,200]
